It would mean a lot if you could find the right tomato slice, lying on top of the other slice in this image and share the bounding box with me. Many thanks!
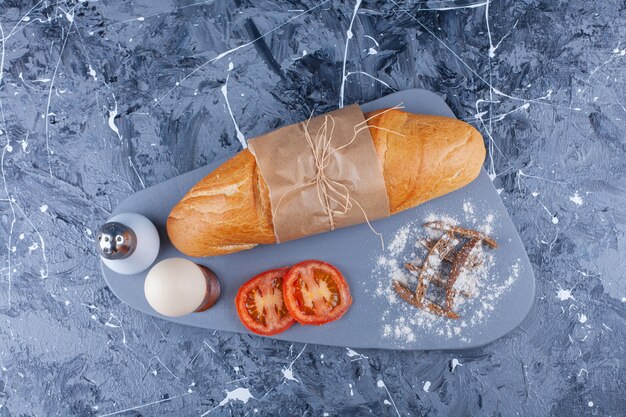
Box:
[283,260,352,325]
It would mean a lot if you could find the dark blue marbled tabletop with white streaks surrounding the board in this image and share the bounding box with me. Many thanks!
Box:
[0,0,626,416]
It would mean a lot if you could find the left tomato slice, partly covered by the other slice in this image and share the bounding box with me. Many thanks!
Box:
[235,268,295,336]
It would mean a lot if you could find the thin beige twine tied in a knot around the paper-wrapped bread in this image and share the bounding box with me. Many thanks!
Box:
[272,103,404,249]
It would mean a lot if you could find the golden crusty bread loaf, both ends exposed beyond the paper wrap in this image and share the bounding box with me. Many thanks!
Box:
[167,110,485,257]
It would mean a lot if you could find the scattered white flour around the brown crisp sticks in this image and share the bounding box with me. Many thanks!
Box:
[373,200,520,344]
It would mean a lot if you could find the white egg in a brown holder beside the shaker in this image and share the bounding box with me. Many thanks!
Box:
[144,258,220,317]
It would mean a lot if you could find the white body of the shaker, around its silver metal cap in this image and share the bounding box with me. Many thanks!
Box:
[100,213,160,275]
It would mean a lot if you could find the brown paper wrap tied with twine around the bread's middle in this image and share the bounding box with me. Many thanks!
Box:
[248,105,390,242]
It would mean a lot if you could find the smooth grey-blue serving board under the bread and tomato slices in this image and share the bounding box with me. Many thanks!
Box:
[102,89,535,350]
